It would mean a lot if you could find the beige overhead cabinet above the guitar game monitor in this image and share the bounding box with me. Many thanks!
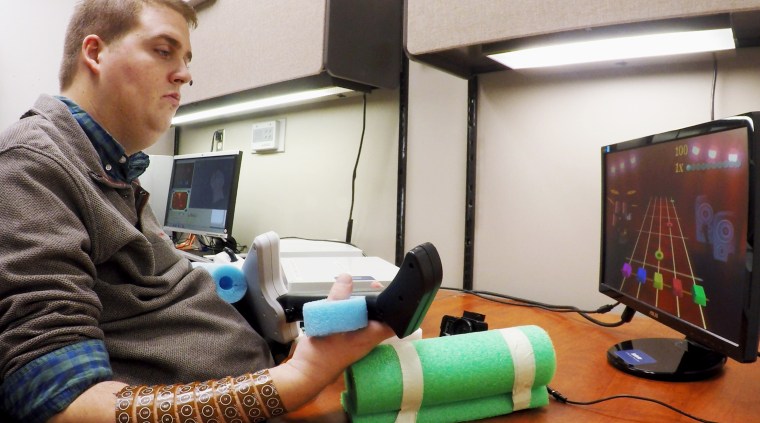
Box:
[404,0,760,76]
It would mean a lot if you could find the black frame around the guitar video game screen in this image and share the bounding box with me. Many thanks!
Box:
[599,112,760,362]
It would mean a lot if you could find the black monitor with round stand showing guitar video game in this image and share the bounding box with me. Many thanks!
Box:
[599,112,760,380]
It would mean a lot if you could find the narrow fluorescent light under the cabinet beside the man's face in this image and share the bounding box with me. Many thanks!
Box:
[172,87,352,125]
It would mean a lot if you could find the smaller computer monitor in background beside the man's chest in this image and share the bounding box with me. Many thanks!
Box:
[164,151,243,240]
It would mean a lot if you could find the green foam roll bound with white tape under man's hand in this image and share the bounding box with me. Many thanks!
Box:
[342,326,556,422]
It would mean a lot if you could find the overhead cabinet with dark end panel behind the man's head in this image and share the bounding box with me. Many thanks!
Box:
[183,0,403,108]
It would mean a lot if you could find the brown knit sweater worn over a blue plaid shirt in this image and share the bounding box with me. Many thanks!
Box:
[0,96,273,384]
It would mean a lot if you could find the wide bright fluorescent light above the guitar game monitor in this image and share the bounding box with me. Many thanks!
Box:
[488,28,735,69]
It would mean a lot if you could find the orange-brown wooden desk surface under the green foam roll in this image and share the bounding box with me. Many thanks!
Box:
[281,290,760,423]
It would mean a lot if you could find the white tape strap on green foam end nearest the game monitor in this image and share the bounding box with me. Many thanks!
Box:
[499,328,536,411]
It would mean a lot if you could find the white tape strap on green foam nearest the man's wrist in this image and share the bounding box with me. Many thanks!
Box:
[391,341,425,423]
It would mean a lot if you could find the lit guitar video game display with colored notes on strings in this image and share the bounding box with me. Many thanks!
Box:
[602,128,750,343]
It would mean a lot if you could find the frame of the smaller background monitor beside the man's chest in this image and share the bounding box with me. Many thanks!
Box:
[164,150,243,240]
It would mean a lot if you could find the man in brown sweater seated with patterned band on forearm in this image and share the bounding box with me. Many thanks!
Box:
[0,0,392,423]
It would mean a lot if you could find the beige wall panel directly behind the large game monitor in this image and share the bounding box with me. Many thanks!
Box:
[474,49,760,307]
